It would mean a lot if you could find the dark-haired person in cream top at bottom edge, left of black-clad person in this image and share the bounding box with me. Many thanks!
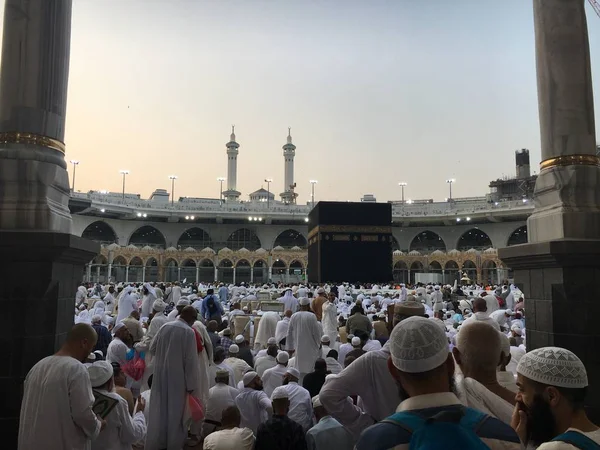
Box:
[202,406,254,450]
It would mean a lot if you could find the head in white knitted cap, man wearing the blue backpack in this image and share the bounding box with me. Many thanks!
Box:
[388,317,454,398]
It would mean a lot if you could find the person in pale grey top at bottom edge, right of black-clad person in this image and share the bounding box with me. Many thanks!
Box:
[306,394,354,450]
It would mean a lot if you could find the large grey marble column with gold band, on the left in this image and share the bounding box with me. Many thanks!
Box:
[0,0,100,442]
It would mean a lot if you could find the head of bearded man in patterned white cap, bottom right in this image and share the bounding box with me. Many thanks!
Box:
[516,347,588,445]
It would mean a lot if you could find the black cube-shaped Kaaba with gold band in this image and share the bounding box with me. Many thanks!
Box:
[307,202,392,283]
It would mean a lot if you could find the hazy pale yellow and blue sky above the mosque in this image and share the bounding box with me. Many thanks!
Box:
[1,0,600,203]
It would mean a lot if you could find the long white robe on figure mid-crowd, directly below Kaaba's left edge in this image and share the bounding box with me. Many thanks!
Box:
[286,311,323,374]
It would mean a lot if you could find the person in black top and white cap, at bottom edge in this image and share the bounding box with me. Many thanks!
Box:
[254,386,307,450]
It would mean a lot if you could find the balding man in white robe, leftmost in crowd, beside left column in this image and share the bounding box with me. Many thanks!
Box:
[18,323,106,450]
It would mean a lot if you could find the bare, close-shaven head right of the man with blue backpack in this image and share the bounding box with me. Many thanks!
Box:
[452,322,502,381]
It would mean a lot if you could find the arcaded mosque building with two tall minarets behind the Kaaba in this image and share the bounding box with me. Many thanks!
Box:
[69,127,536,283]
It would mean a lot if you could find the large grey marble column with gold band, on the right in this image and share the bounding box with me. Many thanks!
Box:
[499,0,600,421]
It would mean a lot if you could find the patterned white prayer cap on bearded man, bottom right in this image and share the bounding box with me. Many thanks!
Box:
[517,347,588,389]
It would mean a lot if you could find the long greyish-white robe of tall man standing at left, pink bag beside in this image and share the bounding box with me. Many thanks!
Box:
[145,320,200,450]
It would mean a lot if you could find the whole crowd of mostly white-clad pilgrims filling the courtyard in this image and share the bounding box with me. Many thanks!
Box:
[19,283,600,450]
